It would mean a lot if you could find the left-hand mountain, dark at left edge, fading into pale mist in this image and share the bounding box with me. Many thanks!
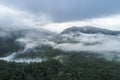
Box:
[0,28,53,57]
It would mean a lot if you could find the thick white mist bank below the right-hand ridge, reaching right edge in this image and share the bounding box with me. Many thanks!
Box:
[54,34,120,53]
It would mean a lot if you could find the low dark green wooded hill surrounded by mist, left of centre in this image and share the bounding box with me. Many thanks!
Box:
[15,45,66,59]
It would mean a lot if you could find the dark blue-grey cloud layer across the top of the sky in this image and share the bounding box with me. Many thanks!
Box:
[0,0,120,22]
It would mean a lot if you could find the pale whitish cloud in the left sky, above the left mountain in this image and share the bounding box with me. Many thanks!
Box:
[0,5,51,28]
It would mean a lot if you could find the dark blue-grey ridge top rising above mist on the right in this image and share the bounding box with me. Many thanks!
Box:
[61,26,120,35]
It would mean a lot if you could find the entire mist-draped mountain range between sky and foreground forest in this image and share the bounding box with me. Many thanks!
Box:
[0,26,120,61]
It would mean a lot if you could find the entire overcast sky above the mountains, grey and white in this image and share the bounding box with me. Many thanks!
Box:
[0,0,120,32]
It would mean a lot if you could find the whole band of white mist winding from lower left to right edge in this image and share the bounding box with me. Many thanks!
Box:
[0,26,120,62]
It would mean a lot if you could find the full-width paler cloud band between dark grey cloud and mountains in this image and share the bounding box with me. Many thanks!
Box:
[0,5,120,32]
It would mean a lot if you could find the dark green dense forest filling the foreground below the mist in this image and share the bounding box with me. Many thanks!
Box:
[0,51,120,80]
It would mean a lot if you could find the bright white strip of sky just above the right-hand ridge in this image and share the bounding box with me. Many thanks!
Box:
[43,15,120,32]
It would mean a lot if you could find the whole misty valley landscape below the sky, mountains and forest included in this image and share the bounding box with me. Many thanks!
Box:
[0,26,120,80]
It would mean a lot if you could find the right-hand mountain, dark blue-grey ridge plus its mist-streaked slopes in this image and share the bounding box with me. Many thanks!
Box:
[51,26,120,44]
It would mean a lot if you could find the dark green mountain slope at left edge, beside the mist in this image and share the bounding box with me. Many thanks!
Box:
[0,36,20,57]
